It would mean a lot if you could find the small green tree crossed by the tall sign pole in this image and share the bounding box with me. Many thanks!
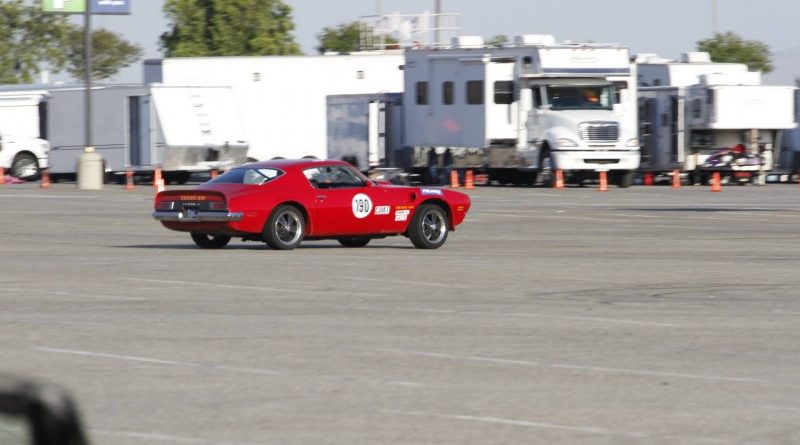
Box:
[67,26,142,80]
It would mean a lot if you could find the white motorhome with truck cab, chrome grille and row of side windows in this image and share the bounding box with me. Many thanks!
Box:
[403,35,639,186]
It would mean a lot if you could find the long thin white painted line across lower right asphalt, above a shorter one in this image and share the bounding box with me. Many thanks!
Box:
[378,349,772,384]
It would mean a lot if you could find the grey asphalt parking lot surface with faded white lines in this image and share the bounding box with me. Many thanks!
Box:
[0,184,800,445]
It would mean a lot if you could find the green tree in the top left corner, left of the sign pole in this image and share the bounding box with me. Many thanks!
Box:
[0,0,70,83]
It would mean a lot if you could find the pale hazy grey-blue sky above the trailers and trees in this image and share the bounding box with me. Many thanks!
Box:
[76,0,800,82]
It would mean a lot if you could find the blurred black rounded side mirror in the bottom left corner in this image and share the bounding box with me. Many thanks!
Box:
[0,374,88,445]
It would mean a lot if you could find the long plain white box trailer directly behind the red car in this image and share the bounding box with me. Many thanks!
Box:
[152,51,403,160]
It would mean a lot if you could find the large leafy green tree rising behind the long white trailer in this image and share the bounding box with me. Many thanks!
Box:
[161,0,301,57]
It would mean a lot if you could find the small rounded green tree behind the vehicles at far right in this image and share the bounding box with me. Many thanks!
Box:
[697,31,772,73]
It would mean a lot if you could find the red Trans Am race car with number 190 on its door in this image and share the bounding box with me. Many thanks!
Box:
[153,159,470,250]
